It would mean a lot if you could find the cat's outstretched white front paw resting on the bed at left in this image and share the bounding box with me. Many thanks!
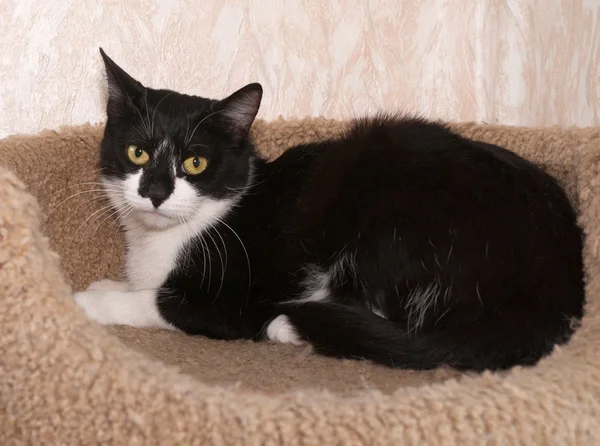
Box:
[74,290,174,329]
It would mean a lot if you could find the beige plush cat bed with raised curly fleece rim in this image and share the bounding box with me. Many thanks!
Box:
[0,119,600,445]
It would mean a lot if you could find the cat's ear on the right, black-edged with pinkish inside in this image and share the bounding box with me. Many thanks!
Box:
[215,83,262,141]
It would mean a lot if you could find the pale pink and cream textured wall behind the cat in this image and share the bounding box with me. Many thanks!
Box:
[0,0,600,136]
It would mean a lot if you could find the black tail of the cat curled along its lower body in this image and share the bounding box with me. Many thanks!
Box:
[280,302,552,370]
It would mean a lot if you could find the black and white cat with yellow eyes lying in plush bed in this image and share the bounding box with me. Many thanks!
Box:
[75,48,584,370]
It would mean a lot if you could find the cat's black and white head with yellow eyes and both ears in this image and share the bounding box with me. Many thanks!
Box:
[100,49,262,229]
